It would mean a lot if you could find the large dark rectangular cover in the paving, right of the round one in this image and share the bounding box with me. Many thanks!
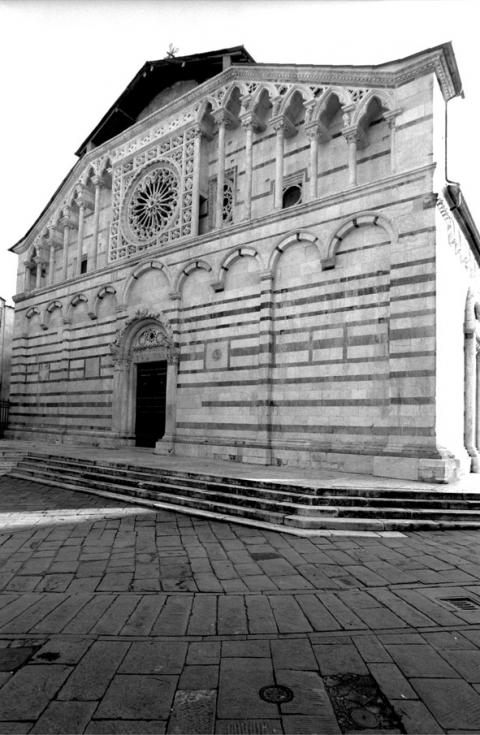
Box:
[323,674,405,732]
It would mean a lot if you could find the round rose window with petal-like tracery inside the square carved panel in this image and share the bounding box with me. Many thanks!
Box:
[126,165,179,242]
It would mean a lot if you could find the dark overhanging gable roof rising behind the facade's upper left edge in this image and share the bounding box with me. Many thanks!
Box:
[75,46,255,156]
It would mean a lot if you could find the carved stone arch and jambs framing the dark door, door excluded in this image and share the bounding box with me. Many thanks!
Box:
[110,309,178,454]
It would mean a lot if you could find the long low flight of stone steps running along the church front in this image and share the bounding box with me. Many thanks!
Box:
[4,451,480,533]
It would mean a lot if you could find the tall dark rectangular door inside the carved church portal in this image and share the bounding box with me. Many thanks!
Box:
[135,360,167,447]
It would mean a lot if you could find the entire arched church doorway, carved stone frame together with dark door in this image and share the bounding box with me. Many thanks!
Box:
[111,309,178,453]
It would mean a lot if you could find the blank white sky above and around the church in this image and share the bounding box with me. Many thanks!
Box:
[0,0,480,301]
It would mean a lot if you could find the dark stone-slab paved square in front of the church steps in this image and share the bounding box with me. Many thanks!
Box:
[0,477,480,733]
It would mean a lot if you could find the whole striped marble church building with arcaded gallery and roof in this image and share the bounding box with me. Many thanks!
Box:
[7,44,480,482]
